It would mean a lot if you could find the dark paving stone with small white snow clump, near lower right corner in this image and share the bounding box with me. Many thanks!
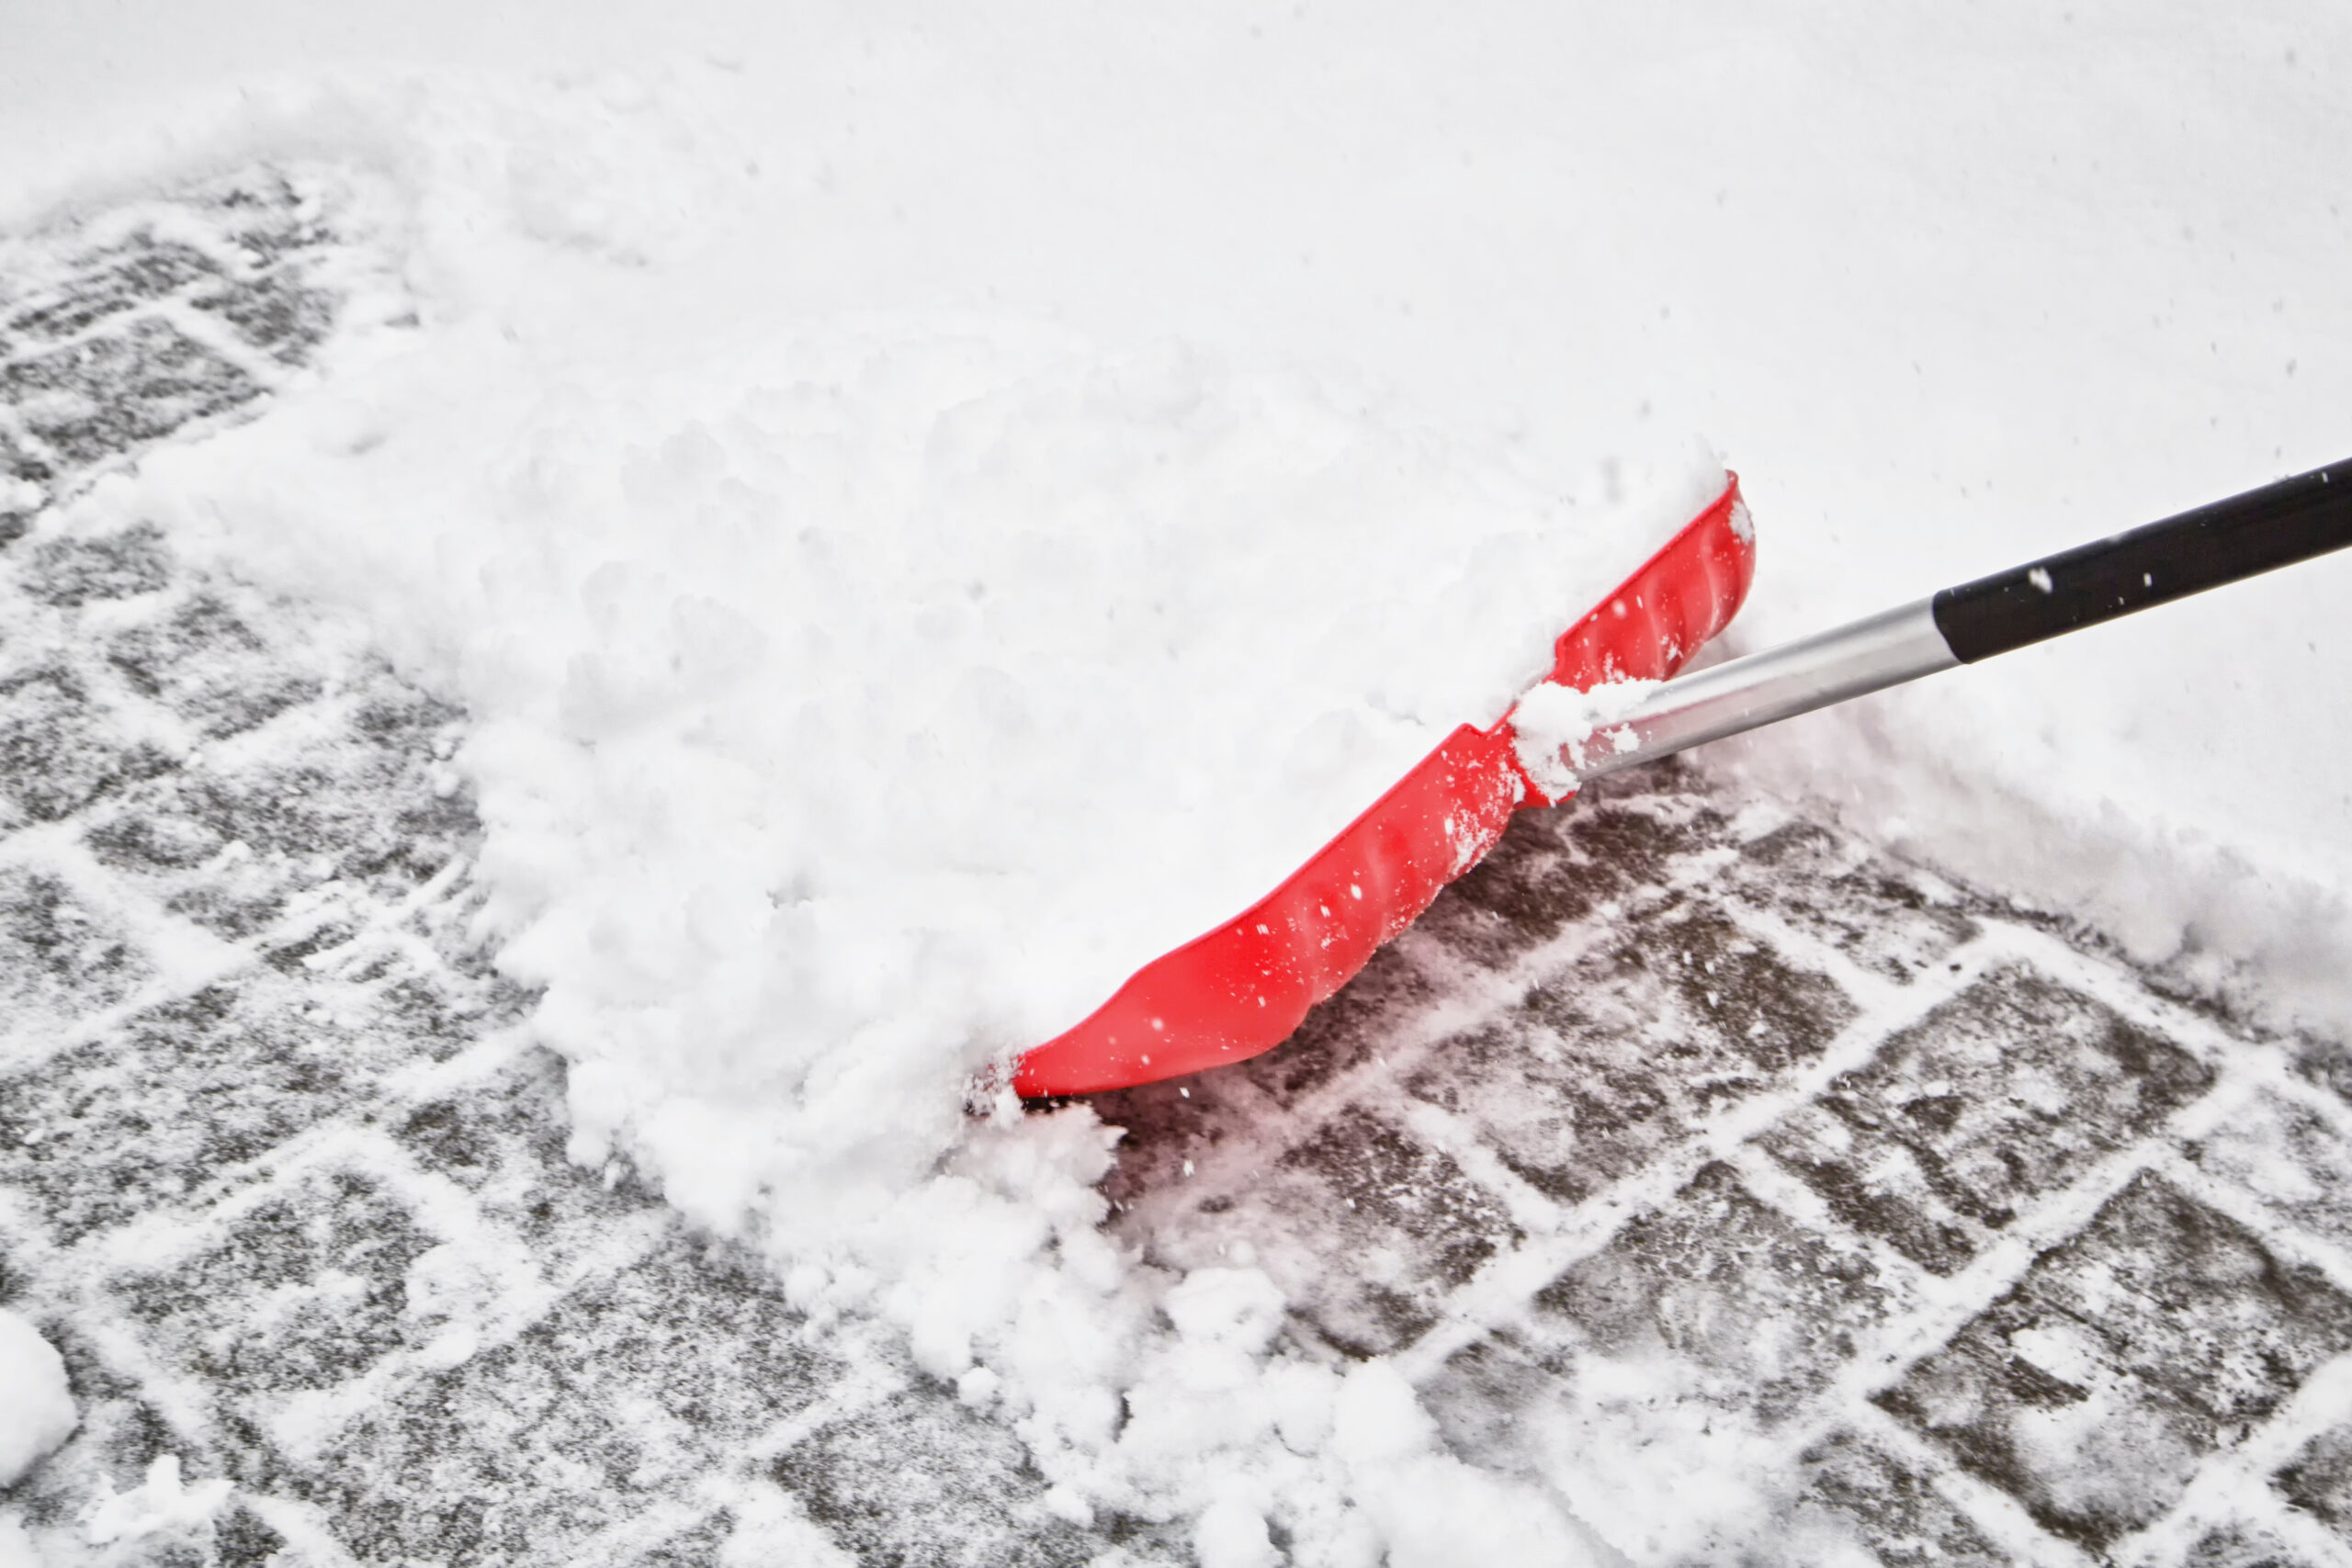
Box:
[1879,1176,2352,1551]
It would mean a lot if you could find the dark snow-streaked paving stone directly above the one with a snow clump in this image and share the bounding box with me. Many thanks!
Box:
[1757,966,2213,1274]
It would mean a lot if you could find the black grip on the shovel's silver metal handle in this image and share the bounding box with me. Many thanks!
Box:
[1936,461,2352,665]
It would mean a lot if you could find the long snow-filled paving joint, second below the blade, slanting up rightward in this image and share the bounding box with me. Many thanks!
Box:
[1395,926,1983,1382]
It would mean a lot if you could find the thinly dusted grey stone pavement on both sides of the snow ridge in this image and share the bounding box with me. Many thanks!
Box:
[0,169,2352,1568]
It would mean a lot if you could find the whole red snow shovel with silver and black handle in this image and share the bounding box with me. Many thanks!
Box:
[1013,461,2352,1096]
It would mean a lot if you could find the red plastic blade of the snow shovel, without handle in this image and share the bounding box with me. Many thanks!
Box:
[1013,475,1755,1098]
